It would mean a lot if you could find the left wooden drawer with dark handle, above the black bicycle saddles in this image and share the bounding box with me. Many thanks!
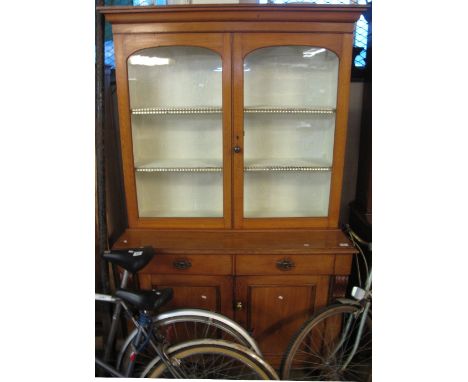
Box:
[140,254,232,275]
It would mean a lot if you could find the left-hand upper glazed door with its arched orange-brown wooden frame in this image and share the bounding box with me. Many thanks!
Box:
[115,33,231,228]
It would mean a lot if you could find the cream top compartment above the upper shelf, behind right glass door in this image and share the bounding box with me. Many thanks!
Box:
[244,46,338,107]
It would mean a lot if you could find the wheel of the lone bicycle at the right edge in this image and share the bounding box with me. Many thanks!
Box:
[281,304,372,382]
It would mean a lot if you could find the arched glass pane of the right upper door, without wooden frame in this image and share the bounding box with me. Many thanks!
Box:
[244,46,339,218]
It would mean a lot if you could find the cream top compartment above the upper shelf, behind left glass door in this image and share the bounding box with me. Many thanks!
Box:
[128,46,222,109]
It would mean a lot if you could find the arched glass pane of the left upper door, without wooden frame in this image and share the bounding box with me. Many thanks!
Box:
[128,46,223,218]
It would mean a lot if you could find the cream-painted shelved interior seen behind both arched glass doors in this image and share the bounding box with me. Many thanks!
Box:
[128,46,352,217]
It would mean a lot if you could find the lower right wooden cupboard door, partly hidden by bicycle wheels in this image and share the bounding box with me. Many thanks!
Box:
[234,276,329,367]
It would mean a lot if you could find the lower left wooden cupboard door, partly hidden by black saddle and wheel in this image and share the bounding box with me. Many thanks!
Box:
[140,274,233,318]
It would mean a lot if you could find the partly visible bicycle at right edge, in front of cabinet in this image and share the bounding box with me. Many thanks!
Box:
[280,226,372,382]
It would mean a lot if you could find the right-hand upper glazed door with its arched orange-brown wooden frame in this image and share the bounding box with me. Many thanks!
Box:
[233,33,351,228]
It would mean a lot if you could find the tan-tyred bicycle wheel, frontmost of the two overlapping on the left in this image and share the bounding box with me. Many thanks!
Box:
[141,339,279,380]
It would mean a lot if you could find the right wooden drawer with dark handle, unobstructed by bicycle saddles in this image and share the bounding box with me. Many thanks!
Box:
[236,255,335,275]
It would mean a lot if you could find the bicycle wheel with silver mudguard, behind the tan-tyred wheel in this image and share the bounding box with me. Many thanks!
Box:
[117,309,261,375]
